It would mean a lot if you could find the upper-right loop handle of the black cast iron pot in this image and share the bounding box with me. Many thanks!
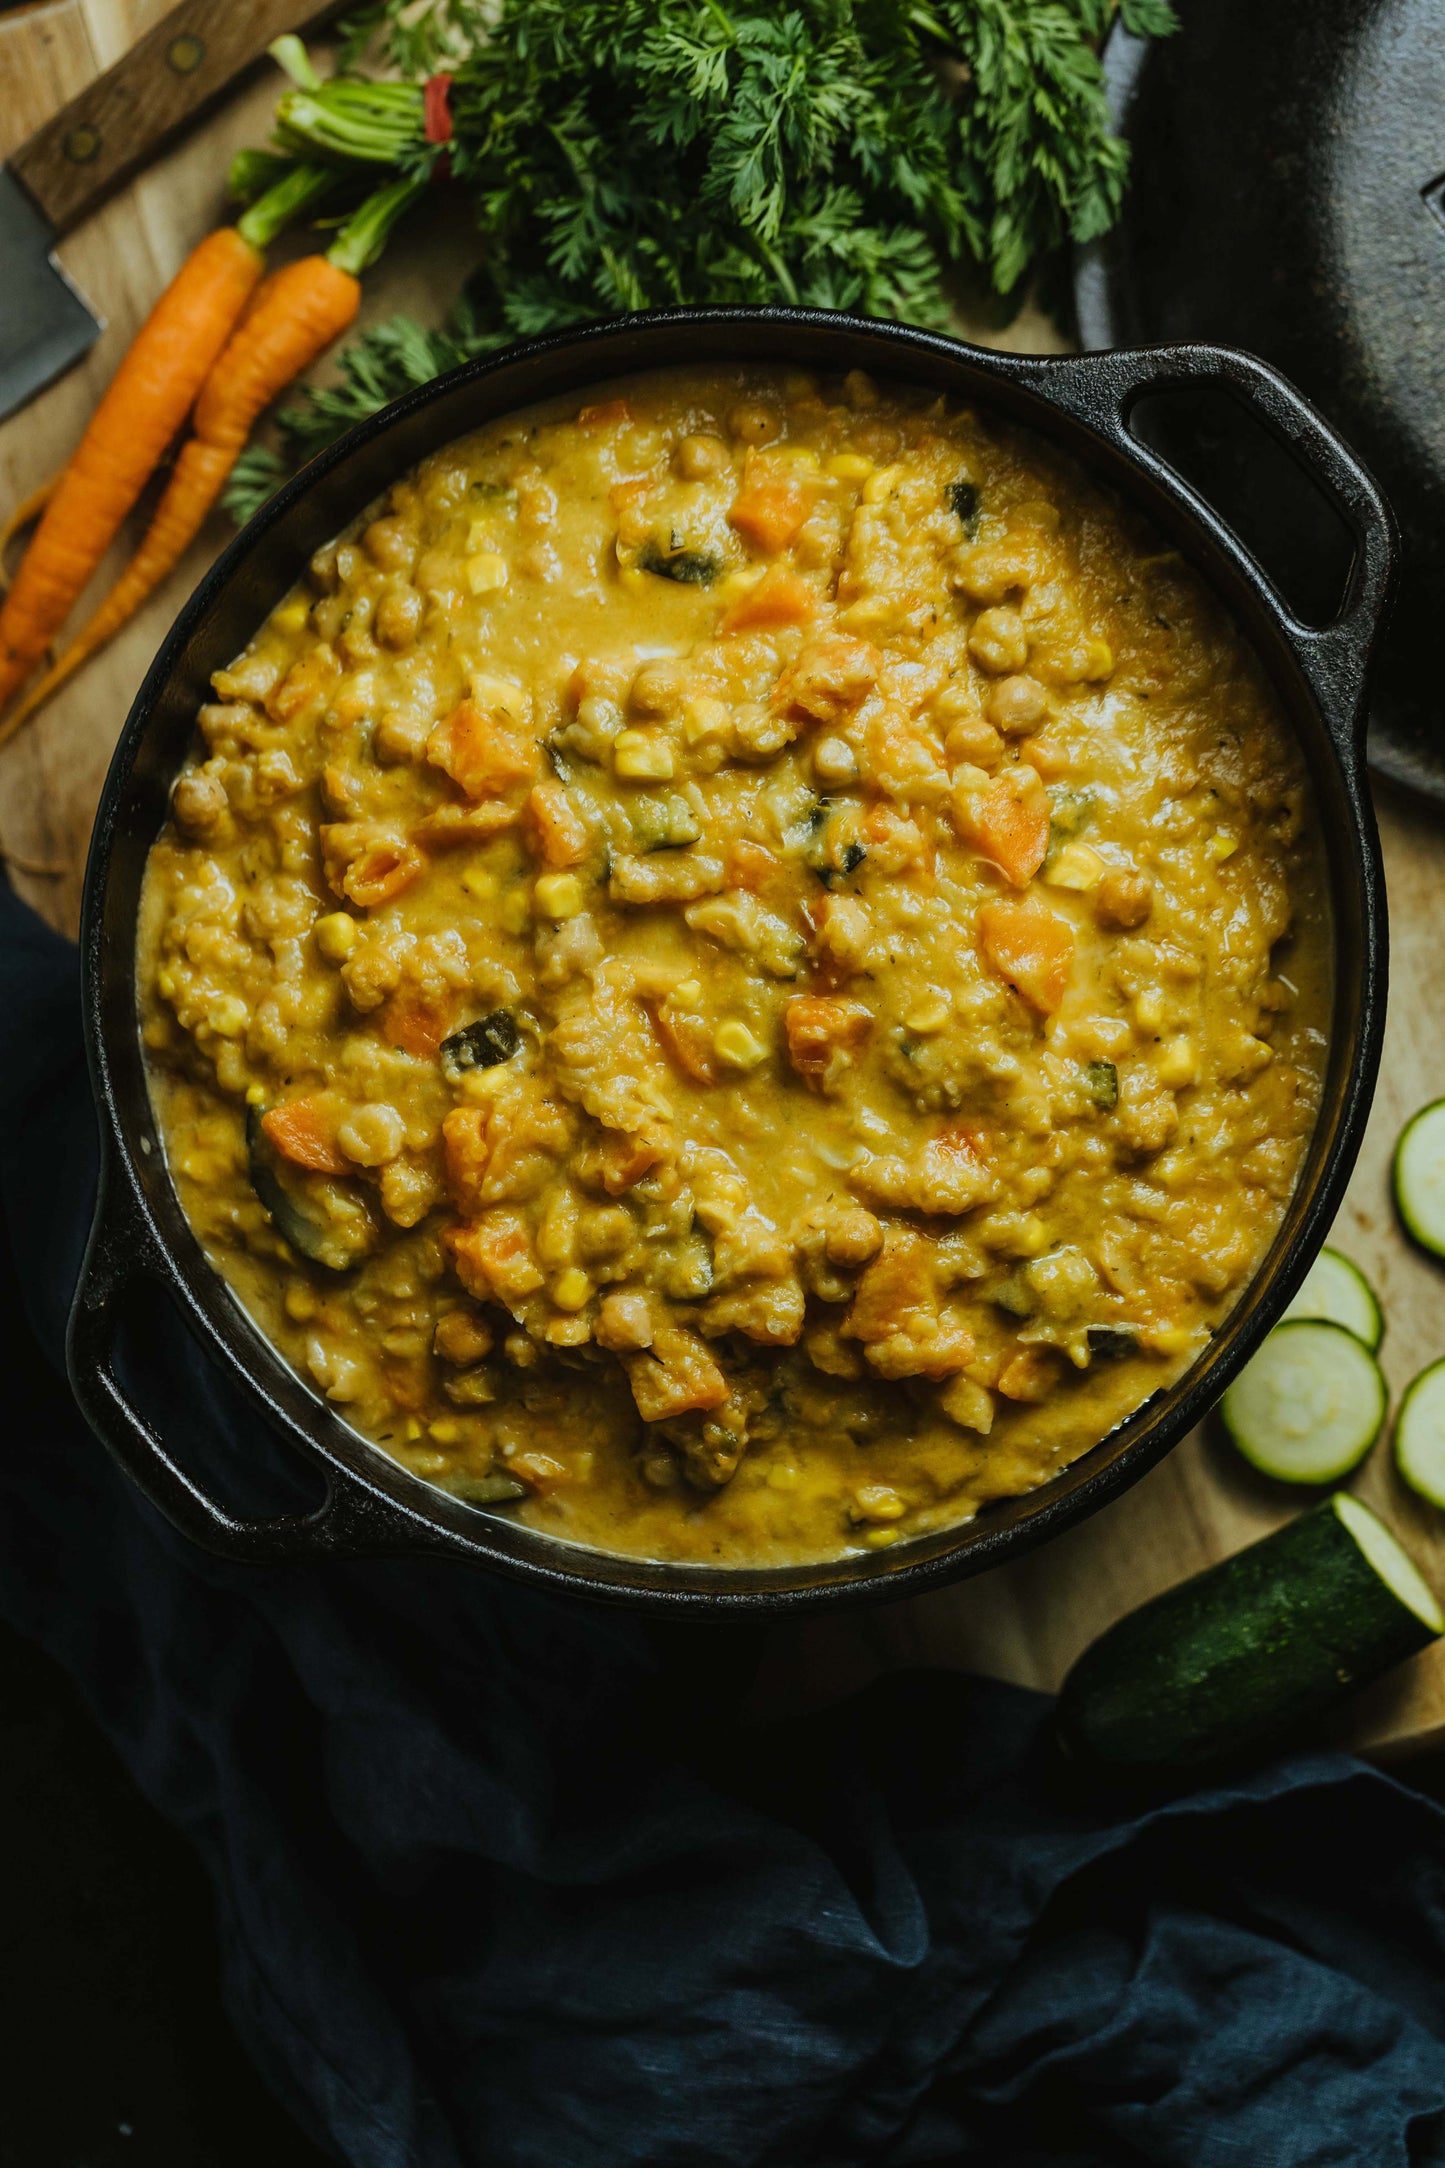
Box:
[1040,347,1395,759]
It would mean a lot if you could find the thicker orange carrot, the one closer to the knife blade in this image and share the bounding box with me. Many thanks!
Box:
[0,167,334,707]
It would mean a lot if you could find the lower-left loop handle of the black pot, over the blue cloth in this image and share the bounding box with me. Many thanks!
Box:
[65,1164,438,1565]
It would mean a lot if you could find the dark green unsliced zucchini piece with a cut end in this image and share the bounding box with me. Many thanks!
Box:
[1055,1492,1445,1773]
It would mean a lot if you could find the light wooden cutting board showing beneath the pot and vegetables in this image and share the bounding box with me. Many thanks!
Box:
[0,0,1445,1752]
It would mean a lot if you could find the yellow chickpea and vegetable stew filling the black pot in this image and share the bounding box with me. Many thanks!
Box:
[139,369,1330,1567]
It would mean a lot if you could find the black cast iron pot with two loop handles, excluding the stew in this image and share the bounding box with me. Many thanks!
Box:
[69,308,1393,1613]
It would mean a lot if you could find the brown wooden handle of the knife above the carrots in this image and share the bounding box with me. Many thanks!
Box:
[9,0,329,234]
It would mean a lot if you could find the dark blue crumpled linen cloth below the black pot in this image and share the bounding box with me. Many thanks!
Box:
[0,893,1445,2168]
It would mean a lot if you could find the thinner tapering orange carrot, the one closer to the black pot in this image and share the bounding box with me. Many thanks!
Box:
[0,180,425,746]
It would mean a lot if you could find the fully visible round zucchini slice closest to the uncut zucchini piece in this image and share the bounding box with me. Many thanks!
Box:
[1220,1318,1389,1483]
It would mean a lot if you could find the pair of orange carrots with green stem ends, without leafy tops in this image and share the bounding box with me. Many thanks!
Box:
[0,144,422,744]
